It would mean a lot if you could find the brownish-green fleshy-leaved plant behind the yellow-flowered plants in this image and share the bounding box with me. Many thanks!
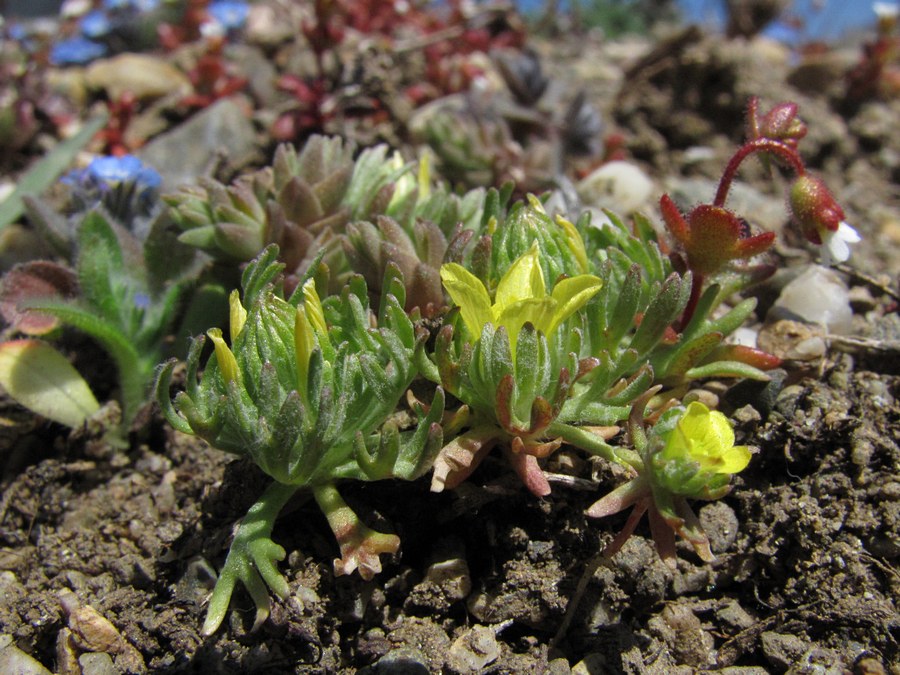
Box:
[164,136,486,315]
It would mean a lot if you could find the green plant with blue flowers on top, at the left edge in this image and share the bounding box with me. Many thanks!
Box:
[0,156,206,430]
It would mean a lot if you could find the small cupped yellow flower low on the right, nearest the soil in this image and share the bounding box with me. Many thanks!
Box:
[662,401,751,474]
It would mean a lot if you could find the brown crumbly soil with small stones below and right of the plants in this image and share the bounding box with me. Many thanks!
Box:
[0,25,900,674]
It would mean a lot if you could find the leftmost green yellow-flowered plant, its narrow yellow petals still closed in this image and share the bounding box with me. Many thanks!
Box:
[157,246,443,634]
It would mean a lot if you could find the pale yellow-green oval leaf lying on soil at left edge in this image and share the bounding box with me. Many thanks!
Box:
[0,340,100,427]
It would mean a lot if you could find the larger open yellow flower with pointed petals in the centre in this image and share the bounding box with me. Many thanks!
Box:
[441,242,600,357]
